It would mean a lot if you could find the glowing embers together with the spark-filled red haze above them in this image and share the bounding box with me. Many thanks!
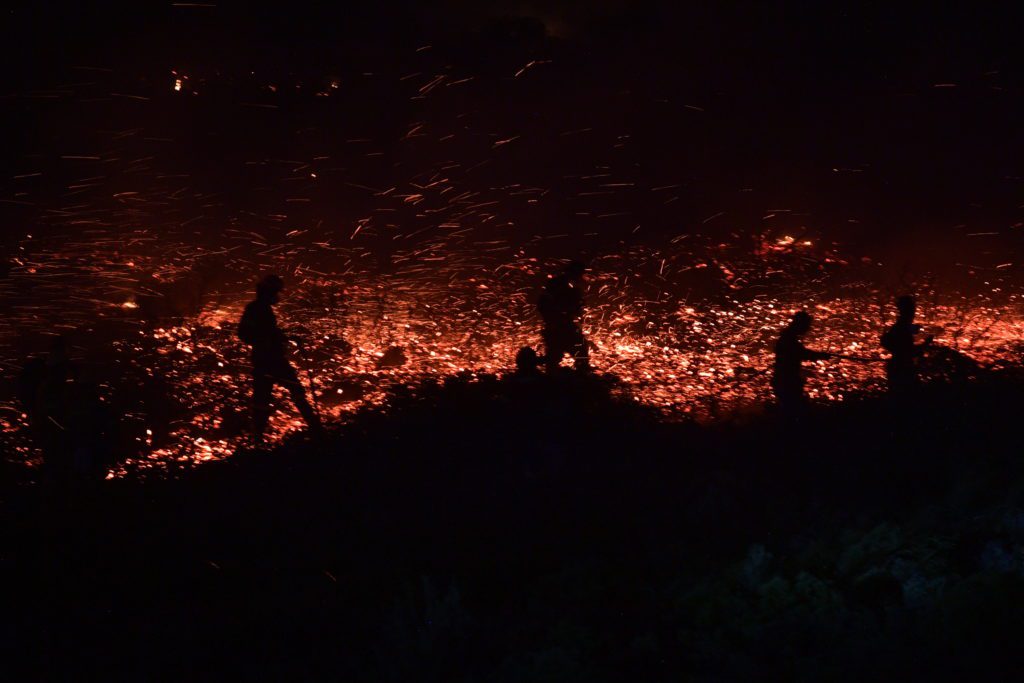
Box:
[0,31,1024,476]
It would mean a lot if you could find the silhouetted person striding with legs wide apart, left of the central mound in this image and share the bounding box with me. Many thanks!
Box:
[239,275,321,441]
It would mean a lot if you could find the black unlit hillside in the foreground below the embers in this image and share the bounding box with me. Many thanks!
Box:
[0,376,1024,682]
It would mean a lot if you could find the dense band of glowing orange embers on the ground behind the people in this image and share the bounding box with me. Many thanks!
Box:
[4,229,1024,472]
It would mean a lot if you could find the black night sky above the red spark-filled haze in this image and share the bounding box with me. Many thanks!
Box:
[8,2,1024,239]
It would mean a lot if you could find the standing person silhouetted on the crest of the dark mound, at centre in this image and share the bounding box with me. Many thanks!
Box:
[537,261,590,372]
